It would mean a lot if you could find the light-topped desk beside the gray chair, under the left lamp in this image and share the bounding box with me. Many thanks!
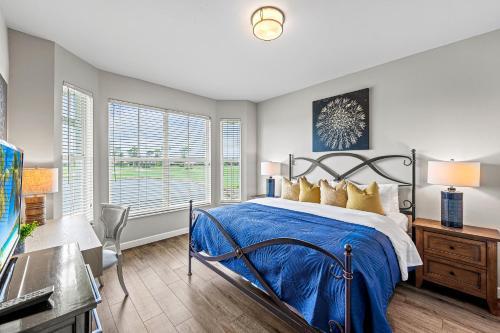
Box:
[25,215,102,277]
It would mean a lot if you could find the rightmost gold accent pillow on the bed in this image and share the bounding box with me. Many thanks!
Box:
[346,182,385,215]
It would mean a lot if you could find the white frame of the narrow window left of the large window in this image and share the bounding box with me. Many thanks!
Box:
[59,81,95,222]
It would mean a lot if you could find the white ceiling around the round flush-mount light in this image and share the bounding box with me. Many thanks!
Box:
[0,0,500,102]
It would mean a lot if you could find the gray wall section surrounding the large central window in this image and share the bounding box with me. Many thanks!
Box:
[94,71,218,242]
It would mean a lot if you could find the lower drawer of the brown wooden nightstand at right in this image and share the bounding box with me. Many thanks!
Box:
[424,256,486,297]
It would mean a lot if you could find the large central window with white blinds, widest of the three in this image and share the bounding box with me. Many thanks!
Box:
[108,100,211,216]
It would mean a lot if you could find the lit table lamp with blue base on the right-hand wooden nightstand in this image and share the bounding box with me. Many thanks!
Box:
[427,160,481,228]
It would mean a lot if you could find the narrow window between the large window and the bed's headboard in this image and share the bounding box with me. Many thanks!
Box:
[220,119,241,201]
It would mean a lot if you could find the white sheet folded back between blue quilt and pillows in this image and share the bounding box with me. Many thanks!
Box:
[249,198,422,281]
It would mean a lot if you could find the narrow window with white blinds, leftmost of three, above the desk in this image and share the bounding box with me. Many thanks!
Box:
[62,83,94,221]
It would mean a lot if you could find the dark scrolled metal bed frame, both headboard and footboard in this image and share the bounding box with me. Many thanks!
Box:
[188,149,416,333]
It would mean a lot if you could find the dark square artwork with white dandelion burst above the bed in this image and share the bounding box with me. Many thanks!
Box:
[313,89,369,152]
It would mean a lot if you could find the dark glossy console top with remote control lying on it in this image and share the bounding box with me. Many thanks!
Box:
[0,243,97,333]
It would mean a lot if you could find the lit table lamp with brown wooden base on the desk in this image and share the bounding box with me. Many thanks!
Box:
[23,168,58,225]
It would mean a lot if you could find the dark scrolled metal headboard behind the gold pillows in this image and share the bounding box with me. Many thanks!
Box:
[288,149,416,221]
